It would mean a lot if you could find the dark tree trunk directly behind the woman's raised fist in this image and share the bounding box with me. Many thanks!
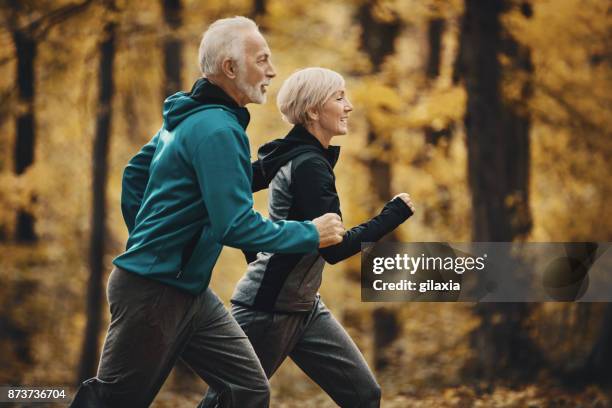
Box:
[357,2,401,370]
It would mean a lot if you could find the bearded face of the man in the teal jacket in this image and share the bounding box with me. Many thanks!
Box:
[236,31,276,104]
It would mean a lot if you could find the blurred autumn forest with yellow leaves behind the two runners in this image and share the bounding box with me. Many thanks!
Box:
[0,0,612,406]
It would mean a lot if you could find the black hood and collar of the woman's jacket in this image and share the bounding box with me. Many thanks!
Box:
[253,125,340,191]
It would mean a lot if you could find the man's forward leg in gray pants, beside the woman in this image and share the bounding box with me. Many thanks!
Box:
[181,289,270,408]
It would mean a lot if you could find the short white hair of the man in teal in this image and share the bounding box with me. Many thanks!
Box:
[198,16,259,75]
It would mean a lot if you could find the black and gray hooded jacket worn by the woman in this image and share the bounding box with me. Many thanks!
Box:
[231,125,412,312]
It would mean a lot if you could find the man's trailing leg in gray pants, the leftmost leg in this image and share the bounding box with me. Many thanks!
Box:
[71,269,196,408]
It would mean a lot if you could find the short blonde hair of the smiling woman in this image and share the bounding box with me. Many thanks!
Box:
[276,67,344,125]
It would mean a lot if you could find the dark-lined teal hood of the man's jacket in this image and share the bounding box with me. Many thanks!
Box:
[163,78,250,130]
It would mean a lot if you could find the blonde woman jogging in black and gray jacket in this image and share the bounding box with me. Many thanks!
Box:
[203,68,413,407]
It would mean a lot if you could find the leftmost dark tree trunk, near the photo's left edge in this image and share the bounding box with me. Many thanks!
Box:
[12,30,37,243]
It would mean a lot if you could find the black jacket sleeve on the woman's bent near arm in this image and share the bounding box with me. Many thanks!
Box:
[291,158,412,264]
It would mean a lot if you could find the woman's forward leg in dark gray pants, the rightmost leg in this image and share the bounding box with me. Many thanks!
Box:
[289,300,381,408]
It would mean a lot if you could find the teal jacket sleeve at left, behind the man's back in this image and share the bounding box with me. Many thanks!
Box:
[121,132,159,233]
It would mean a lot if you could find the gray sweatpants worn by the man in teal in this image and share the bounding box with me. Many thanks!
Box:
[71,268,270,408]
